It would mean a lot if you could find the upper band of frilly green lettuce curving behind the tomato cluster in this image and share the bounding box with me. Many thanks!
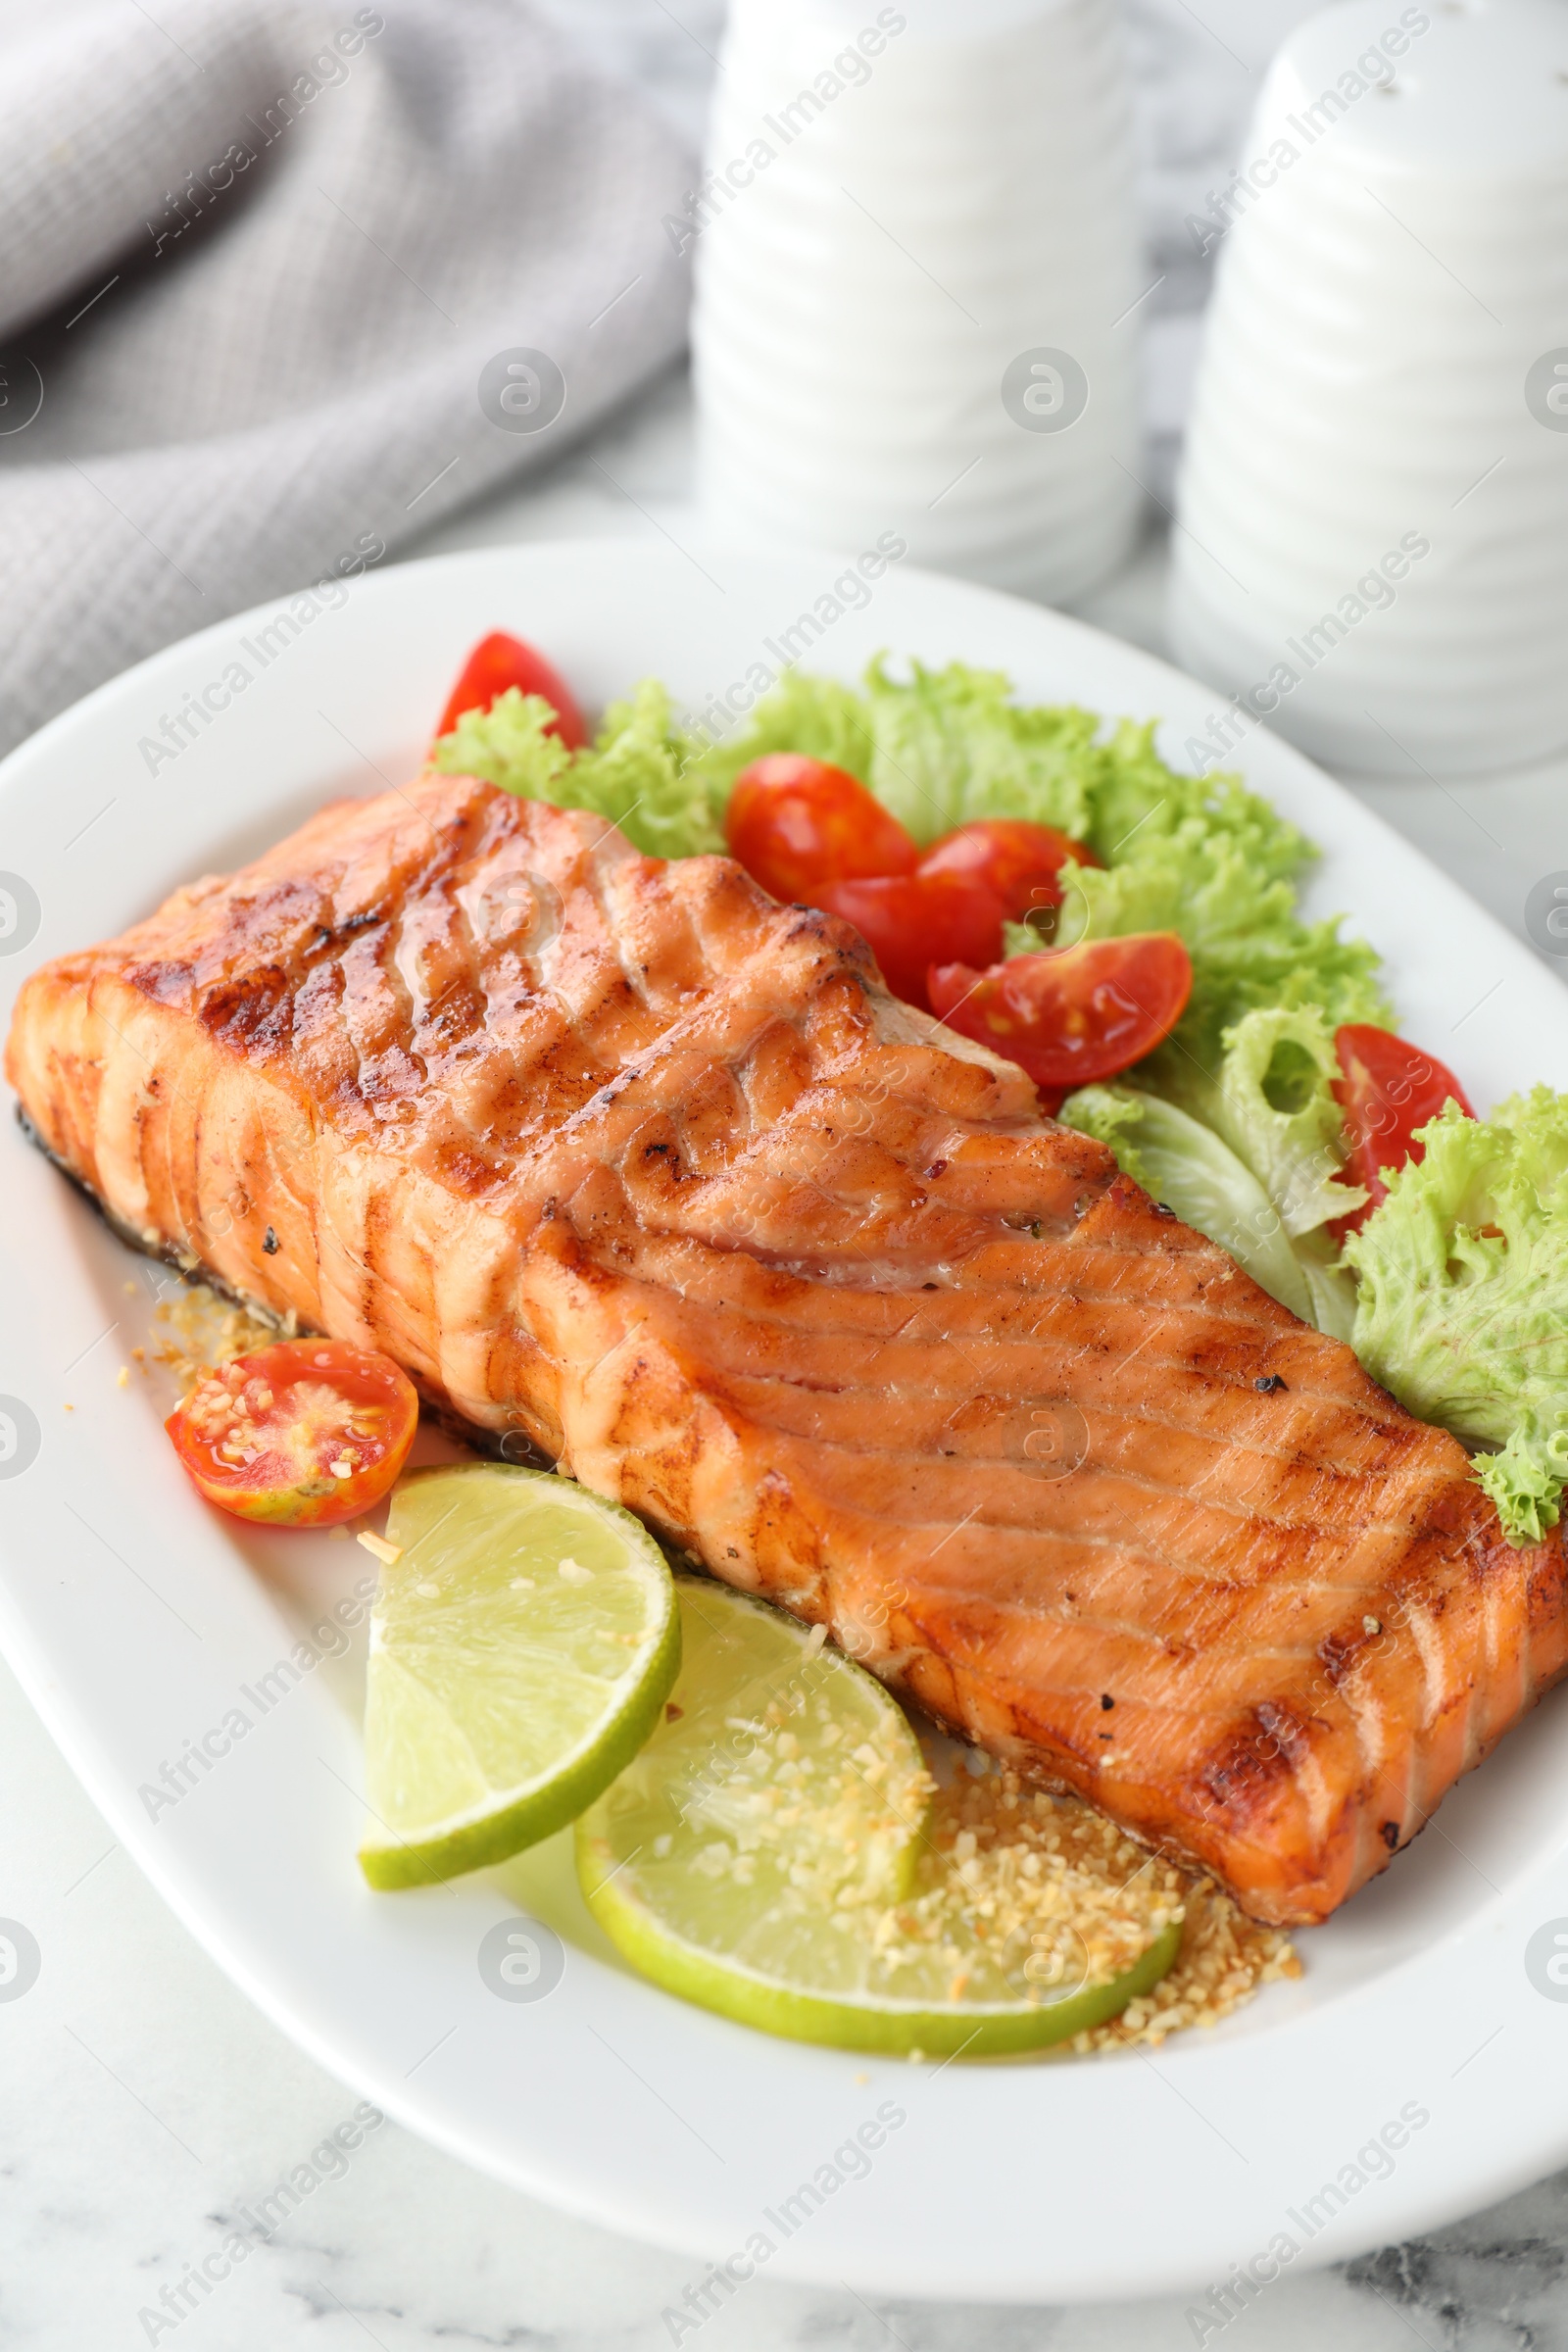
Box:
[435,661,1390,1077]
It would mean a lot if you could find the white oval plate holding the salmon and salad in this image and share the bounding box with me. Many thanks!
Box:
[0,541,1568,2333]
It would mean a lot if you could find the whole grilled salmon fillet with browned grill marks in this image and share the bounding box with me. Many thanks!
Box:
[7,774,1568,1924]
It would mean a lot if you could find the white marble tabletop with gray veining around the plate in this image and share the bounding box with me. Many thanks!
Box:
[0,0,1568,2352]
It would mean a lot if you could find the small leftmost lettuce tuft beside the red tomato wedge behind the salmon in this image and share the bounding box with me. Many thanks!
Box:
[432,677,724,858]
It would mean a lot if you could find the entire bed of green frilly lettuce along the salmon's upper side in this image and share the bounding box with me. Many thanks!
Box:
[432,661,1568,1543]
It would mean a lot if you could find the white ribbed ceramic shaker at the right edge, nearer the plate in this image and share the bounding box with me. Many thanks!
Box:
[1171,0,1568,778]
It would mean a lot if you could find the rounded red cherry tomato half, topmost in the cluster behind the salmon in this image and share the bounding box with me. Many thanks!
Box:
[724,751,919,906]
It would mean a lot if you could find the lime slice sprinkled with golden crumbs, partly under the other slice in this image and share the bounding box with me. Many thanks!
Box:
[576,1576,1180,2056]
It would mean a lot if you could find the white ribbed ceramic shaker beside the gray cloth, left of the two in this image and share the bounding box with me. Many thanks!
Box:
[689,0,1145,602]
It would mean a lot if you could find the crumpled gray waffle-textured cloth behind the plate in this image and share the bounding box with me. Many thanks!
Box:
[0,0,691,751]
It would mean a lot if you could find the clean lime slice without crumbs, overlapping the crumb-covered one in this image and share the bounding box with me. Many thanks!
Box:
[360,1463,679,1886]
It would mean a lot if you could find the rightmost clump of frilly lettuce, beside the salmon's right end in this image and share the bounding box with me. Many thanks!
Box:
[1345,1087,1568,1543]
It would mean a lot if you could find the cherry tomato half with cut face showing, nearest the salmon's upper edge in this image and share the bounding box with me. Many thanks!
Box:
[929,931,1192,1089]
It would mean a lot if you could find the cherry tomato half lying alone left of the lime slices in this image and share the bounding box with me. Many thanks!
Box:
[165,1339,418,1527]
